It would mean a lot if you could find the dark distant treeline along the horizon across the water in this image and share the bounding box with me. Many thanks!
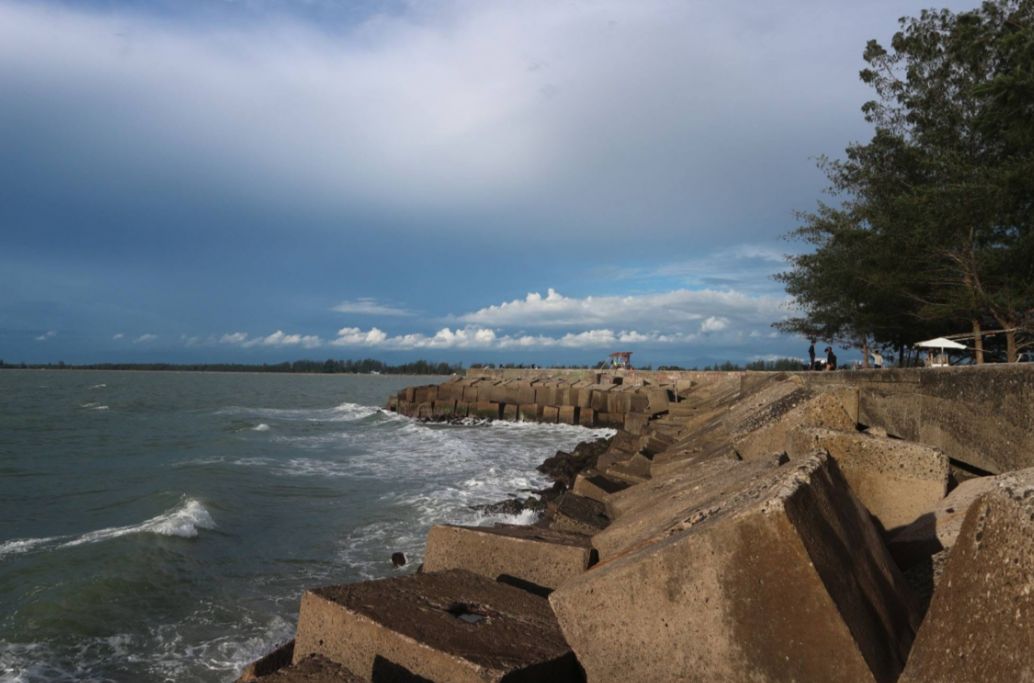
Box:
[0,359,463,375]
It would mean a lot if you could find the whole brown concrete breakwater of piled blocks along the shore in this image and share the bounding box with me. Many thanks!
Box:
[237,366,1034,682]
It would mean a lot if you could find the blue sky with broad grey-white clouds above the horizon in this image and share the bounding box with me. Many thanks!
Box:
[0,0,975,366]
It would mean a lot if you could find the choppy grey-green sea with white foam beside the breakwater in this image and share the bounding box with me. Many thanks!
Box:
[0,370,607,682]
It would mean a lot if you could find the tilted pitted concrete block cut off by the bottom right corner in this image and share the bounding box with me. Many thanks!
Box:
[901,469,1034,683]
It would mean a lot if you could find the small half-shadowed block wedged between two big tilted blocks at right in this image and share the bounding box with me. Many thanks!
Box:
[887,476,998,569]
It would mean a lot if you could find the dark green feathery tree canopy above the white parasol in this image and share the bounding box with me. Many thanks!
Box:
[776,0,1034,362]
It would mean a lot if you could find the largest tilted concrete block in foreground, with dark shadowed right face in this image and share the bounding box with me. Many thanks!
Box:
[550,454,918,682]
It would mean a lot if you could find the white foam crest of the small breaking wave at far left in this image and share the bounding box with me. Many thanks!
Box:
[0,498,215,559]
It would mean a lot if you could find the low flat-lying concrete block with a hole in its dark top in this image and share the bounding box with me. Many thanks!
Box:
[295,569,578,683]
